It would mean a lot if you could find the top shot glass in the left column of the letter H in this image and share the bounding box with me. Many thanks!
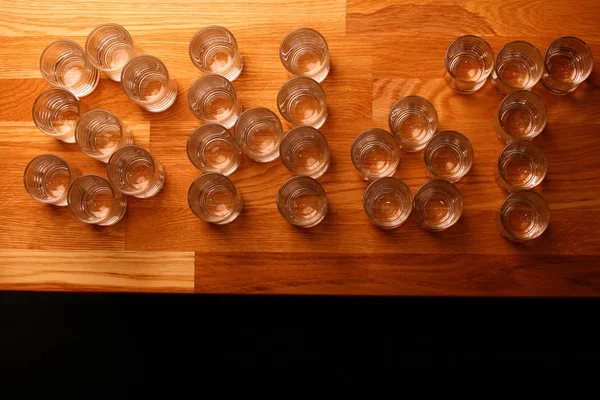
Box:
[190,25,244,82]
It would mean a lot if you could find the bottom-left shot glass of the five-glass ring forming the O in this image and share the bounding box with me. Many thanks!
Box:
[363,177,413,229]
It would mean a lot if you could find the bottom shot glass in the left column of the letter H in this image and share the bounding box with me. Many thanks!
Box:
[188,172,242,225]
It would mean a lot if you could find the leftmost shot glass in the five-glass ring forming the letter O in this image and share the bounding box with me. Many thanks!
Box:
[350,128,400,181]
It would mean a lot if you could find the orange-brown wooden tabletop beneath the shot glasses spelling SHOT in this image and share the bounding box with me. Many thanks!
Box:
[0,0,600,296]
